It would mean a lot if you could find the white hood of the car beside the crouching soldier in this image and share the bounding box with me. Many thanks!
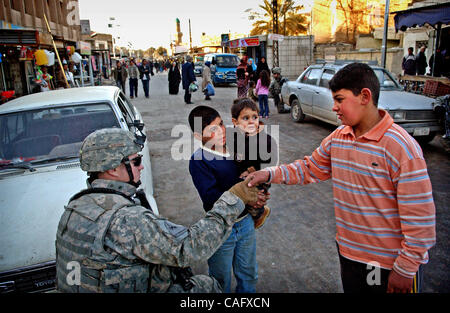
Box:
[0,163,87,272]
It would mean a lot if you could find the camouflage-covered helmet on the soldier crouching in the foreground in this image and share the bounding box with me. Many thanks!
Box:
[80,128,142,172]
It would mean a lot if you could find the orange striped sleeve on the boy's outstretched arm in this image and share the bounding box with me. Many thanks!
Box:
[264,134,333,185]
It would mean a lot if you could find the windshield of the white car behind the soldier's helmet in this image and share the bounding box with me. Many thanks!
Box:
[0,103,120,168]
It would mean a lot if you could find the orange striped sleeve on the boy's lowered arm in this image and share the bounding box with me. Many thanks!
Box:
[393,159,436,278]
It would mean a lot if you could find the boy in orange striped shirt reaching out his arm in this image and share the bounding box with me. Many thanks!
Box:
[249,63,435,292]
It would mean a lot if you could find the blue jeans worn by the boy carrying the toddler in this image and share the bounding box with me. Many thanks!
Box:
[208,214,258,293]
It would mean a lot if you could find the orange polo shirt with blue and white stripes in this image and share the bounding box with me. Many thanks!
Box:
[264,110,436,278]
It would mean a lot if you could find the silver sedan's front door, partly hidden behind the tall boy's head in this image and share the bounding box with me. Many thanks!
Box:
[312,69,338,124]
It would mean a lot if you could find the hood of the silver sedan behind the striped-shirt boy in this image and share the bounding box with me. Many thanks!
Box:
[378,90,434,111]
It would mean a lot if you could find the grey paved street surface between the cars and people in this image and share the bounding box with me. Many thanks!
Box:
[127,73,450,293]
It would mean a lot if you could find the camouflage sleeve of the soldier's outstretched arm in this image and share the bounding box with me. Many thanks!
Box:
[109,191,244,267]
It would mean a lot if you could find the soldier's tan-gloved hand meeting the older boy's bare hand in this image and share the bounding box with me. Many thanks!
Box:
[229,171,270,207]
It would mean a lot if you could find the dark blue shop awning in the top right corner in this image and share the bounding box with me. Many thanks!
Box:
[392,2,450,32]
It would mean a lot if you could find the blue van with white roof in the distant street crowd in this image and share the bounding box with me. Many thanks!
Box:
[204,53,240,86]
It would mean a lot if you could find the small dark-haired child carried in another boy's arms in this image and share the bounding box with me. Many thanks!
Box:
[231,97,278,229]
